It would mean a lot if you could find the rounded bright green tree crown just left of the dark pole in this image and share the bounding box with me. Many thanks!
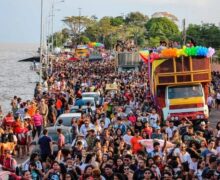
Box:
[145,17,179,39]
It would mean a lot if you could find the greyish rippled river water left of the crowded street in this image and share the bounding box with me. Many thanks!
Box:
[0,44,39,113]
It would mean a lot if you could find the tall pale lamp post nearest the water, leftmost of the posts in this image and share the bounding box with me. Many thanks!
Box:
[39,0,44,84]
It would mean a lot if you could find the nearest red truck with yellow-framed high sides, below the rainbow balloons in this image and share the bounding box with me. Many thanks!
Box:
[150,51,211,121]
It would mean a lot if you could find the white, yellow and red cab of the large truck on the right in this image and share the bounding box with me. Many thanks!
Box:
[163,83,209,120]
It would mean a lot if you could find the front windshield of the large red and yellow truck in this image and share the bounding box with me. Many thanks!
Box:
[168,85,203,99]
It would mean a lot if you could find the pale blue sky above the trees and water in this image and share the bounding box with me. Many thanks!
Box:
[0,0,220,43]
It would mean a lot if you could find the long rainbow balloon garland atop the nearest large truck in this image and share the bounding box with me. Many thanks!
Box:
[139,46,215,62]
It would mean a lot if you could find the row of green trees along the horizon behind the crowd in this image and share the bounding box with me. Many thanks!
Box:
[50,12,220,53]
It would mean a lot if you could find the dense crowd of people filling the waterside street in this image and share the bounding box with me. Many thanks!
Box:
[0,55,220,180]
